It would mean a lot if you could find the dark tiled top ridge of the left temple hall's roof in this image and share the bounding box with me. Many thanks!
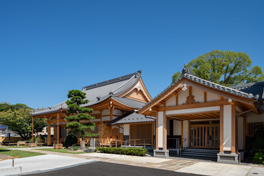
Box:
[82,70,141,90]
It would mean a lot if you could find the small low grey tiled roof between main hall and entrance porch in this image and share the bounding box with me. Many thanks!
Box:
[107,112,156,125]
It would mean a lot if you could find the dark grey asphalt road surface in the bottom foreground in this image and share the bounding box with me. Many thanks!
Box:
[23,162,203,176]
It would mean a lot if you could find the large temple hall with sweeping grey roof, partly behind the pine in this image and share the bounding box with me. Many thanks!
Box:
[31,71,155,146]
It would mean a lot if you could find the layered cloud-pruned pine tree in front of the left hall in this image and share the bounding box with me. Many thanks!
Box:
[65,90,96,140]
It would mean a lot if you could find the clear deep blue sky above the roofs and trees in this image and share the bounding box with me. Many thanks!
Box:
[0,0,264,108]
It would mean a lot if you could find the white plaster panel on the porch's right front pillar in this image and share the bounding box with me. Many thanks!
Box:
[224,105,232,151]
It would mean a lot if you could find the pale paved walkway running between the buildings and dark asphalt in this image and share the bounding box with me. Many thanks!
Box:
[2,148,264,176]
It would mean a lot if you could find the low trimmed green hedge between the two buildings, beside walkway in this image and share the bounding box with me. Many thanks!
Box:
[96,147,148,156]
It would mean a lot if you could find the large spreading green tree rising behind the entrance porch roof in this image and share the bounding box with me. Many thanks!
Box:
[172,50,264,86]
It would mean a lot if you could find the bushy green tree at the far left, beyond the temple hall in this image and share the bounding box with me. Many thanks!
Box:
[0,103,47,140]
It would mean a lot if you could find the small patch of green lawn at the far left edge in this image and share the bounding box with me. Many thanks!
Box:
[0,147,45,158]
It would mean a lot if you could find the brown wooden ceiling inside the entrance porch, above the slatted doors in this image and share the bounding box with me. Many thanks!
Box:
[167,111,220,120]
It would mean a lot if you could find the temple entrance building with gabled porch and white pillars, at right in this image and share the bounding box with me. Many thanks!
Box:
[138,67,264,163]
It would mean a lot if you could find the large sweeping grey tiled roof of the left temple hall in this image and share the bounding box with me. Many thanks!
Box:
[31,71,142,115]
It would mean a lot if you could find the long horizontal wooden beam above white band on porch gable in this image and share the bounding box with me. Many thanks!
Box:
[158,100,230,111]
